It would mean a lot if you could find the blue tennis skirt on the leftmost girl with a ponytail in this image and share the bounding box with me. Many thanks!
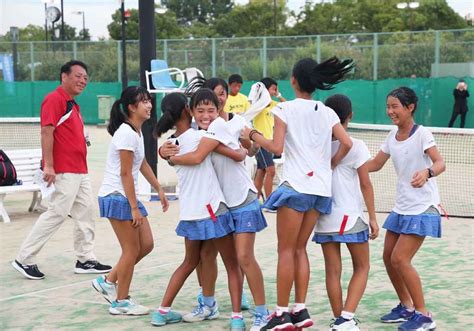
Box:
[99,193,148,221]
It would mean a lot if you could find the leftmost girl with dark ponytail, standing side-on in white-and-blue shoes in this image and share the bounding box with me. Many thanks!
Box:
[92,86,168,315]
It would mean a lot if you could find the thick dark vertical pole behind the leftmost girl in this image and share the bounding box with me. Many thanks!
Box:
[138,0,158,175]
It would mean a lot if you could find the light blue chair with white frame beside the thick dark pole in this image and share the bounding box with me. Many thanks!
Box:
[145,60,185,93]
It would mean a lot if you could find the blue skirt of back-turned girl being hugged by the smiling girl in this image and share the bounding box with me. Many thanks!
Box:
[176,211,235,240]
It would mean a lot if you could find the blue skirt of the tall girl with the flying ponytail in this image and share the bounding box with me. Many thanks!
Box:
[263,185,332,214]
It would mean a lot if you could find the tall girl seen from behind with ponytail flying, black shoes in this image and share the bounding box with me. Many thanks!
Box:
[244,57,353,329]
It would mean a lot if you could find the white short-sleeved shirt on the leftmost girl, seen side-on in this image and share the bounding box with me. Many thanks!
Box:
[98,123,145,197]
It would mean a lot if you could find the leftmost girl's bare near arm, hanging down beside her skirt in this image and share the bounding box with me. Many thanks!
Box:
[120,150,143,228]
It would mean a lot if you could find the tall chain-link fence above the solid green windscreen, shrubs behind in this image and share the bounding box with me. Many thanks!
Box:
[0,29,474,82]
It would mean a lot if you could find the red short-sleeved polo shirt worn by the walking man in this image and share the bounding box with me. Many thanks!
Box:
[41,86,87,174]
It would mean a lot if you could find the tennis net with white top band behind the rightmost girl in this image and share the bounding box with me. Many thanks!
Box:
[349,123,474,217]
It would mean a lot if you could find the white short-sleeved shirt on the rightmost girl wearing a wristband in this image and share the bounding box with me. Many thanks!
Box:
[380,125,440,215]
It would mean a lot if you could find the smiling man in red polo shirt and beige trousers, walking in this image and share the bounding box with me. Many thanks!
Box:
[12,61,112,279]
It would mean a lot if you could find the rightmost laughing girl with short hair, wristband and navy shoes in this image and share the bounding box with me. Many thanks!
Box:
[368,87,445,330]
